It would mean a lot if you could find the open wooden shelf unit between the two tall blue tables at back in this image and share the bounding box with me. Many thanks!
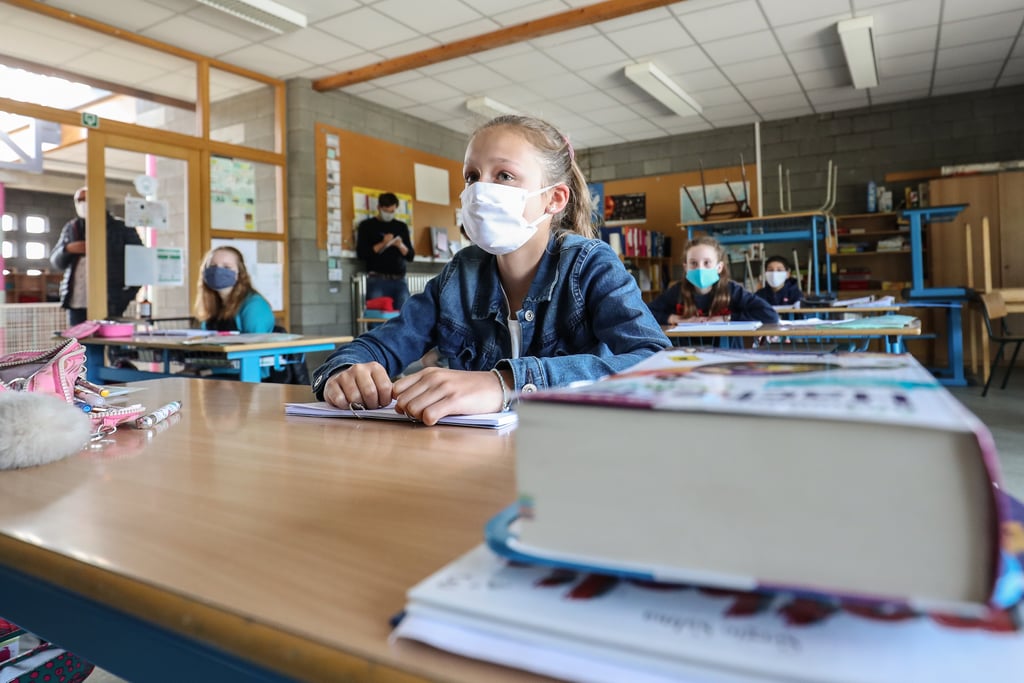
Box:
[831,213,910,300]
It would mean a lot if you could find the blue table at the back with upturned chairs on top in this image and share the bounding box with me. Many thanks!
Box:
[682,211,833,294]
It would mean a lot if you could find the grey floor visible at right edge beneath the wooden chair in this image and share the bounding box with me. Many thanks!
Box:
[79,368,1024,683]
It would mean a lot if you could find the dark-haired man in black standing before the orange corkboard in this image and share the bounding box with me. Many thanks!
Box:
[355,193,416,310]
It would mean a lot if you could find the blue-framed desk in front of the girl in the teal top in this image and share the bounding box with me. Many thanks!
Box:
[80,335,352,383]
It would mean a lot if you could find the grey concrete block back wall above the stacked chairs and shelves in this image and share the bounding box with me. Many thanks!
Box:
[580,86,1024,214]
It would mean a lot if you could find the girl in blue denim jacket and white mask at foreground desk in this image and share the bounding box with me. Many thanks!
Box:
[312,116,669,424]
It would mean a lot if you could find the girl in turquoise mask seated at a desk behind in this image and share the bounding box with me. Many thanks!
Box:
[648,237,778,325]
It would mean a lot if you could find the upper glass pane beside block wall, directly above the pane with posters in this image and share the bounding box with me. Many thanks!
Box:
[210,69,274,152]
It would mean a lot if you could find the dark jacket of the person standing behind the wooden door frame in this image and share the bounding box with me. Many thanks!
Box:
[50,212,142,317]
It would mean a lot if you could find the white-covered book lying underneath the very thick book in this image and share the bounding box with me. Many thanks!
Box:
[392,497,1024,683]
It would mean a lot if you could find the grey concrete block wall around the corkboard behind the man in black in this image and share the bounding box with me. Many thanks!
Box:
[286,79,468,334]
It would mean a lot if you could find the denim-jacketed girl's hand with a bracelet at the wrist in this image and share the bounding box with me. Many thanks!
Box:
[393,368,503,425]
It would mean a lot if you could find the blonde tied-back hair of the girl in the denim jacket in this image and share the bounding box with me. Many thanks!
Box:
[470,114,597,238]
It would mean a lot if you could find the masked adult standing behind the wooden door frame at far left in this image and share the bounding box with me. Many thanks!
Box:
[50,187,142,326]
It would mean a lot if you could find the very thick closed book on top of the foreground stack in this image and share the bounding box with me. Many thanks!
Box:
[510,350,1021,613]
